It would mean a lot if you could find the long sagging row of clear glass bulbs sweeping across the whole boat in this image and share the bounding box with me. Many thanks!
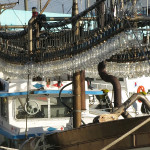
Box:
[0,28,145,79]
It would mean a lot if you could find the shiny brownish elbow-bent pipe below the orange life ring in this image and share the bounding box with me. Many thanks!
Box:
[113,93,150,116]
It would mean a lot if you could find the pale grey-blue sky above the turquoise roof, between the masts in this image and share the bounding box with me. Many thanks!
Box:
[0,0,150,13]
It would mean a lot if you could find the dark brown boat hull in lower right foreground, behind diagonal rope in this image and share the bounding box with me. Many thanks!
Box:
[42,116,150,150]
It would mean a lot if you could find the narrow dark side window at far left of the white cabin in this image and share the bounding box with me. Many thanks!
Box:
[0,97,8,119]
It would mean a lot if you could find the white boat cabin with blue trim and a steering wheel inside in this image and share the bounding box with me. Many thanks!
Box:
[0,80,103,148]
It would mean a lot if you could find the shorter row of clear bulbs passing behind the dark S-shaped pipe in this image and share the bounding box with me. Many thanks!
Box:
[85,61,150,78]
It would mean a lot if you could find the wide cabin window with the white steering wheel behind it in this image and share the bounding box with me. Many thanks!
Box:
[15,96,73,119]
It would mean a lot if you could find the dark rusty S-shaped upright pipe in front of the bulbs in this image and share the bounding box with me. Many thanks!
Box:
[98,61,121,107]
